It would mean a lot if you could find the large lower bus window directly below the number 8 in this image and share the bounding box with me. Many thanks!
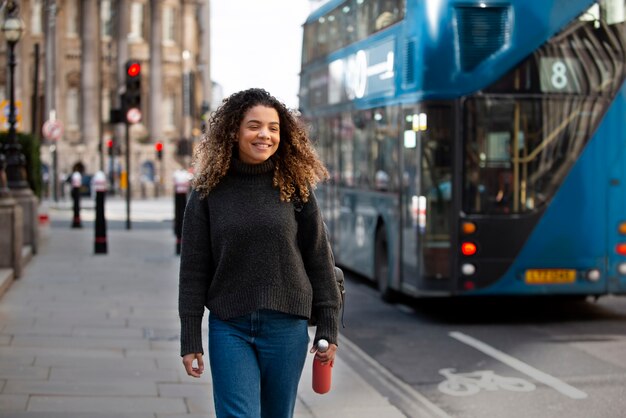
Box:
[463,98,603,214]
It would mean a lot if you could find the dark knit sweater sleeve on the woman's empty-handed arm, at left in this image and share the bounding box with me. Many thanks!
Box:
[178,191,214,356]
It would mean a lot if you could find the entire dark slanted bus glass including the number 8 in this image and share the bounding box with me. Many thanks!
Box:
[462,5,624,214]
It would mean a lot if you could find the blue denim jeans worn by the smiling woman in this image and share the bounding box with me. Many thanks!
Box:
[209,310,309,418]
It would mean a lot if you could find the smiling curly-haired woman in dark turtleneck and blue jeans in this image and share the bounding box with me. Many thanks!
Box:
[179,89,340,418]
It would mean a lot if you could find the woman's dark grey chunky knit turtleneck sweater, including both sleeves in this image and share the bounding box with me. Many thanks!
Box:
[178,159,340,355]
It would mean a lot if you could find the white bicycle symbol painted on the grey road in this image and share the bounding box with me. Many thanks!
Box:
[438,368,535,396]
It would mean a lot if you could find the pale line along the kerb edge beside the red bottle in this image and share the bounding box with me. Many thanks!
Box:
[337,335,451,418]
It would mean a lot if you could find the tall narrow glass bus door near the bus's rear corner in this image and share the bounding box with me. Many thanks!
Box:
[401,103,455,294]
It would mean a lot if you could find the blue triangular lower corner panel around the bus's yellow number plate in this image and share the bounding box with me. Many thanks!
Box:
[476,92,626,295]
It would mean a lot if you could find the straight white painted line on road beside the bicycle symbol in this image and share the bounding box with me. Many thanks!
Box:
[449,331,587,399]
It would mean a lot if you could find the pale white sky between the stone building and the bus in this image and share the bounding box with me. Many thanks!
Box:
[211,0,311,107]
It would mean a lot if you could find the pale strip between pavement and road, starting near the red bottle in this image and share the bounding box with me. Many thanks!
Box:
[337,335,451,418]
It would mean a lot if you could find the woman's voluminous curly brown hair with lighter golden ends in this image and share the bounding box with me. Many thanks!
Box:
[192,89,328,202]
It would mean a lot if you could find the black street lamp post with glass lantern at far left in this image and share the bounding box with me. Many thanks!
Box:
[2,9,28,189]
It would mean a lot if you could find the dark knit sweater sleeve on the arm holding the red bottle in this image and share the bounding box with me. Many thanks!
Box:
[298,193,341,344]
